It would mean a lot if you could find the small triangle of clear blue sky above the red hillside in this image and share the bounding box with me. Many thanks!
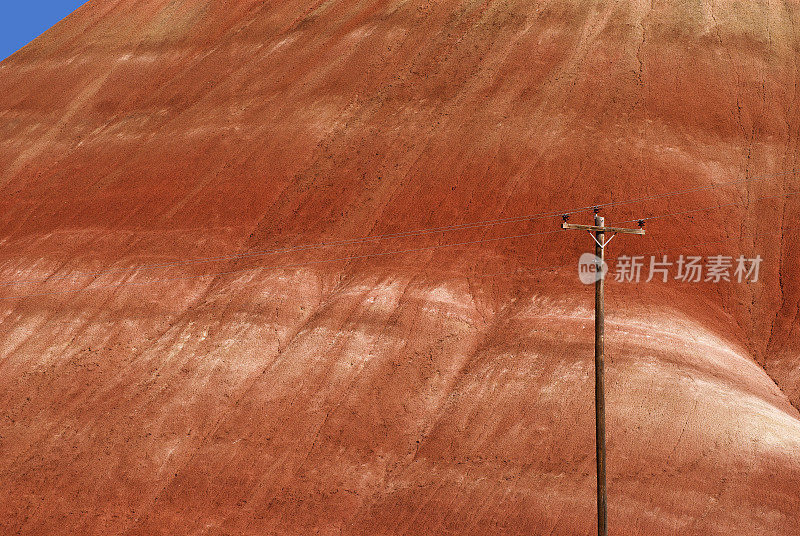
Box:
[0,0,86,60]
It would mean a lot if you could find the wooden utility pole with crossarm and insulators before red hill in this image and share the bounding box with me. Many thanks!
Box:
[561,208,644,536]
